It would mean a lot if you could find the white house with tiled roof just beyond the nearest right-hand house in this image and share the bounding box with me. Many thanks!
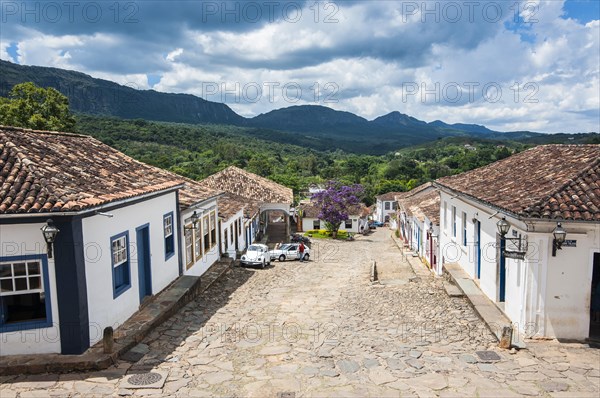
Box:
[396,183,442,275]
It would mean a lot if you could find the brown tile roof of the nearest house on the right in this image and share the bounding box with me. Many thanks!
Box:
[437,145,600,221]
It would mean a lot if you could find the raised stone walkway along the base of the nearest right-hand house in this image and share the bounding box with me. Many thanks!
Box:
[444,264,527,349]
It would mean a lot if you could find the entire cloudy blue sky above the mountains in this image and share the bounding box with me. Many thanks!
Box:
[0,0,600,133]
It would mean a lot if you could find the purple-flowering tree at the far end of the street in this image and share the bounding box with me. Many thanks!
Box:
[312,181,364,238]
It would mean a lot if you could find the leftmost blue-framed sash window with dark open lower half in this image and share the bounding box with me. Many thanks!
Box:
[0,255,52,332]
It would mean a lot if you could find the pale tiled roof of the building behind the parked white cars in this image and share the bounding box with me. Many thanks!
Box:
[202,166,294,205]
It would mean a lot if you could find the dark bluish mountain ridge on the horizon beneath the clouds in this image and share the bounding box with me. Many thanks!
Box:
[0,60,540,154]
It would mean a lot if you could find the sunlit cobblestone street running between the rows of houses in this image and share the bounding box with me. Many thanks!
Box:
[0,228,600,398]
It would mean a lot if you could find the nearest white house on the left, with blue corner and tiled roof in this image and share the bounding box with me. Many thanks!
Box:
[0,127,223,356]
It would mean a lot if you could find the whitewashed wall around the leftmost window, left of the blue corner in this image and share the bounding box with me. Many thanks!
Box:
[0,223,61,355]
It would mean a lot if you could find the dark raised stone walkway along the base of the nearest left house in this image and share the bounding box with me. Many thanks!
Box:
[0,261,232,376]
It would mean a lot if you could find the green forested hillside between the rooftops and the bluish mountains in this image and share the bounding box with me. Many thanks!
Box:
[77,115,552,203]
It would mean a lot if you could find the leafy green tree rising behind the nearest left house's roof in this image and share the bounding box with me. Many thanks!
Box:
[0,82,75,132]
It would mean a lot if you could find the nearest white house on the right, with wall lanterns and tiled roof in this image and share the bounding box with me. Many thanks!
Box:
[436,145,600,341]
